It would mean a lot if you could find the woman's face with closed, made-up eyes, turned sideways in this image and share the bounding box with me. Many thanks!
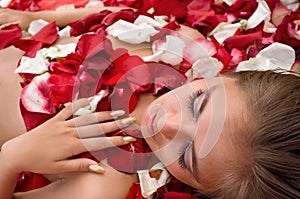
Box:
[142,77,246,190]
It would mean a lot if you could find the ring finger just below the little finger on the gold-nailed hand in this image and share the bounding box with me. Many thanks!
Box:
[67,110,125,127]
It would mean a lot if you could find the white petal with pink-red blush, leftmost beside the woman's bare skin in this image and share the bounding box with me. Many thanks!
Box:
[21,73,55,114]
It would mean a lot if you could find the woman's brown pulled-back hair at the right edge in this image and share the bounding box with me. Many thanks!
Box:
[204,71,300,199]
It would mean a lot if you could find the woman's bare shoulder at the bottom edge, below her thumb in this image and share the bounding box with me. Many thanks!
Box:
[15,163,137,199]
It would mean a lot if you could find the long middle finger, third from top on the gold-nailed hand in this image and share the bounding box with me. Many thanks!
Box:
[76,117,135,138]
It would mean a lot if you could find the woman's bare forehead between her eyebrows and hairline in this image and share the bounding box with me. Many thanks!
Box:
[191,77,246,187]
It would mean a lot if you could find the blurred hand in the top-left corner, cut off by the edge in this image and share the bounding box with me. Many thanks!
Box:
[0,8,33,30]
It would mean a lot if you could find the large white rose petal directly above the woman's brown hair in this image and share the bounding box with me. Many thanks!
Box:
[236,43,295,71]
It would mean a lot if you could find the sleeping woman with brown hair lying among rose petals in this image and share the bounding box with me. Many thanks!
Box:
[0,6,300,199]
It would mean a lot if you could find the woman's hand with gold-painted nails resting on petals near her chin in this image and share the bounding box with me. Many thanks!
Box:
[1,99,135,174]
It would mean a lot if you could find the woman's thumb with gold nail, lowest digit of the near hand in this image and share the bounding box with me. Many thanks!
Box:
[58,158,104,174]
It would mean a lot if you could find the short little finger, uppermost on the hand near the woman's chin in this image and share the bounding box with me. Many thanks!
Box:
[55,98,90,120]
